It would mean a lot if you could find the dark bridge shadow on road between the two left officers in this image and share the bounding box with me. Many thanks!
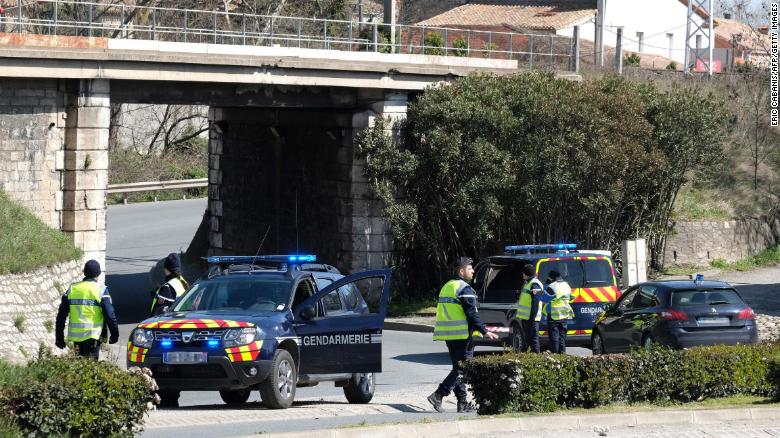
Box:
[106,272,152,324]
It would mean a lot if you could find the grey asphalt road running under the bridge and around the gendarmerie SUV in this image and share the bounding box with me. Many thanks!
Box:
[106,199,590,437]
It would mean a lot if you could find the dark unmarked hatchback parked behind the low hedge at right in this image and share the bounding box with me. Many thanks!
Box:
[592,280,758,354]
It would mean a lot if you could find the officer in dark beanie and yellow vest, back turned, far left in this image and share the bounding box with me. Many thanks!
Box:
[55,260,119,360]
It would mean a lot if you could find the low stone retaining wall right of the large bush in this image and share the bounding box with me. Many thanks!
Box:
[664,218,780,266]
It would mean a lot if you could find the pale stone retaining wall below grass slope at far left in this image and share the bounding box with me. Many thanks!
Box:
[0,260,83,362]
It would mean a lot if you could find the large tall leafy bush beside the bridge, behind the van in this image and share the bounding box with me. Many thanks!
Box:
[358,72,725,295]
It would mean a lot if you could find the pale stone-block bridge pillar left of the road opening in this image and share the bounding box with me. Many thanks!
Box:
[62,79,111,269]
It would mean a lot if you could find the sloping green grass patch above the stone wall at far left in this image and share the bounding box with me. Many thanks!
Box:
[0,191,82,275]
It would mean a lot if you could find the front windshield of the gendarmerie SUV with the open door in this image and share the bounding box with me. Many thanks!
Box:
[173,276,290,312]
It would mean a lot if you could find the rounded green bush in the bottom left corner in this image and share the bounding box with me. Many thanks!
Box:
[0,349,156,437]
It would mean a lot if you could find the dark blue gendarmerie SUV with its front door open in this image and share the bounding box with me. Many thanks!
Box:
[127,255,391,409]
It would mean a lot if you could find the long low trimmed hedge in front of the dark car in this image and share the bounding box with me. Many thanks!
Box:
[466,344,780,414]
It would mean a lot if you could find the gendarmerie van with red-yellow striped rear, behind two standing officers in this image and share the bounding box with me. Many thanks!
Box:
[474,244,620,351]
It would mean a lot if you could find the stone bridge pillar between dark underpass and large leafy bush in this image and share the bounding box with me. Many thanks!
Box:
[340,93,408,271]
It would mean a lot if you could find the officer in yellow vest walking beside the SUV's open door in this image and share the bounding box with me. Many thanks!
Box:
[428,257,498,412]
